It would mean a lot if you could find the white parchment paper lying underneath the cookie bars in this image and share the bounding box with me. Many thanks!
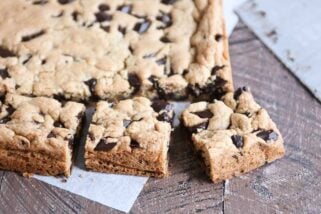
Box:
[34,0,243,212]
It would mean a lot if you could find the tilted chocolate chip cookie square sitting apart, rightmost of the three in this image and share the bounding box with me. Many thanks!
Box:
[182,87,285,182]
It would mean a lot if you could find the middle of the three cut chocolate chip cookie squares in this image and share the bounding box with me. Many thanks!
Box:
[85,97,174,177]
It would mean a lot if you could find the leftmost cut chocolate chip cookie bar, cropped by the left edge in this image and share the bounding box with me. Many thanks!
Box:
[0,94,85,176]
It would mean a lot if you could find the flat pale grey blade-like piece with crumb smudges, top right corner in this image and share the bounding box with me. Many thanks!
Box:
[237,0,321,101]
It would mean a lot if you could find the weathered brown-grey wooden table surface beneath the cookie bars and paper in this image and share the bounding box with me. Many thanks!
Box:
[0,23,321,214]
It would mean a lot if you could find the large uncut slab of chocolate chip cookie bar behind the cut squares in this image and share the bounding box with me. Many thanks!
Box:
[0,0,233,100]
